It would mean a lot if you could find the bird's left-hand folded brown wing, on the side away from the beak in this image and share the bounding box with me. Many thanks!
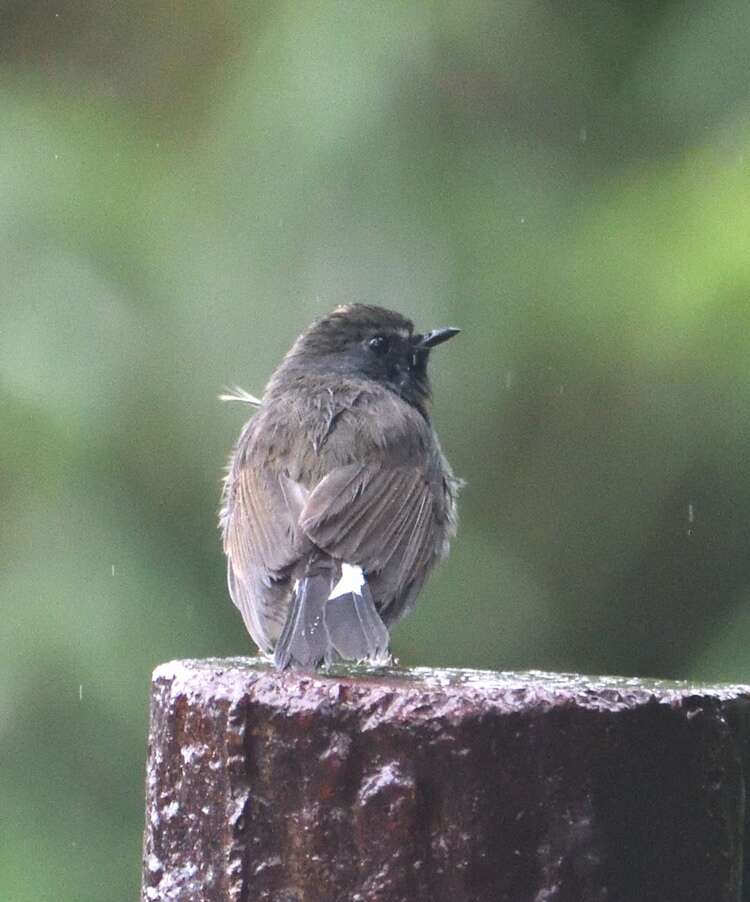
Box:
[222,468,310,653]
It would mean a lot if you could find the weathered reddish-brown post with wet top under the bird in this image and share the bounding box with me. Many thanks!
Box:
[143,659,750,902]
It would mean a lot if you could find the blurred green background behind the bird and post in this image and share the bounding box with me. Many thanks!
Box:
[0,0,750,902]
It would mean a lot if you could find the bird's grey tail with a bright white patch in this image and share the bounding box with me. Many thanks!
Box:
[274,561,390,670]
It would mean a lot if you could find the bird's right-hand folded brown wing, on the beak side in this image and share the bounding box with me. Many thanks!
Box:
[299,464,437,623]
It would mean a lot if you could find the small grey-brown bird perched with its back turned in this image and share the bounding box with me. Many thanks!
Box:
[220,304,462,670]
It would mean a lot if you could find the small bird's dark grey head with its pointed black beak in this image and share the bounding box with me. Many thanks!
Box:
[284,304,457,412]
